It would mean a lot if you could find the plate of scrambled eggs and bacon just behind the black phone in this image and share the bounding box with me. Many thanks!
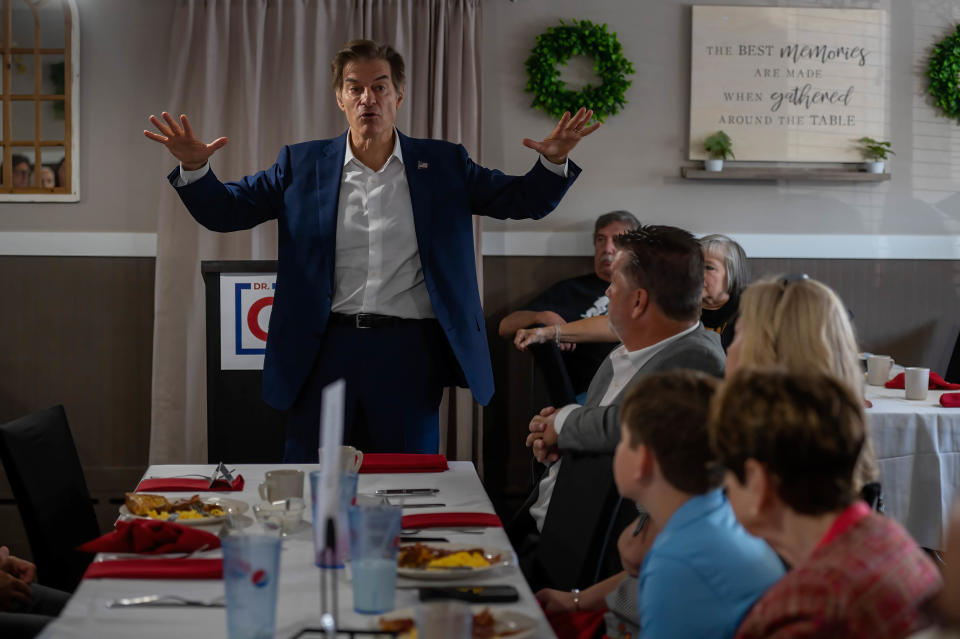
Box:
[397,543,513,579]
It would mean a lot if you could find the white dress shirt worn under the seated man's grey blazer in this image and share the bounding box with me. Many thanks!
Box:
[530,322,700,532]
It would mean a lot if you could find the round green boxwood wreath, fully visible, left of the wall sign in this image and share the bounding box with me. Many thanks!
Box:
[526,20,633,122]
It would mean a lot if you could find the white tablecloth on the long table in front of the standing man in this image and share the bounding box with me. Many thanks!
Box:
[35,462,555,639]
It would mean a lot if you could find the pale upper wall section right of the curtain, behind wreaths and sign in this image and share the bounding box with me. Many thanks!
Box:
[482,0,960,258]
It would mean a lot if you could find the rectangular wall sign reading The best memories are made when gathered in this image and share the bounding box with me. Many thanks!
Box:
[689,5,888,162]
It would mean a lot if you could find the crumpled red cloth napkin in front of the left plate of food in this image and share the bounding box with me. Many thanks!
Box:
[77,519,220,554]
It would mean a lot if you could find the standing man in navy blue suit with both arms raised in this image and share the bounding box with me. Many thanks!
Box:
[144,40,599,462]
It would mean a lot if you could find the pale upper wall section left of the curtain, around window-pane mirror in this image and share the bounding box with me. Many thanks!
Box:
[0,0,174,235]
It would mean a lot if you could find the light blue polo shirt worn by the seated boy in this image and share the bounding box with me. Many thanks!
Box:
[637,488,784,639]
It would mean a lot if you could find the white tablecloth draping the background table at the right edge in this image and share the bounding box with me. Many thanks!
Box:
[866,386,960,549]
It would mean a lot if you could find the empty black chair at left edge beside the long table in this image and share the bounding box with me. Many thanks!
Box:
[0,406,100,592]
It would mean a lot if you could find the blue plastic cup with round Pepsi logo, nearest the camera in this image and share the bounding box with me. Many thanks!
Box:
[222,535,280,639]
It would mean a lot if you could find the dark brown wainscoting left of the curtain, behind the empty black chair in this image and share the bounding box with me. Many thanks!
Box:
[0,256,154,557]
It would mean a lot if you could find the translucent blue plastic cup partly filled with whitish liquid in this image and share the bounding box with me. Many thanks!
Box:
[349,505,403,615]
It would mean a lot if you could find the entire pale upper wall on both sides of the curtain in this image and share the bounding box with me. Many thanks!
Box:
[0,0,960,252]
